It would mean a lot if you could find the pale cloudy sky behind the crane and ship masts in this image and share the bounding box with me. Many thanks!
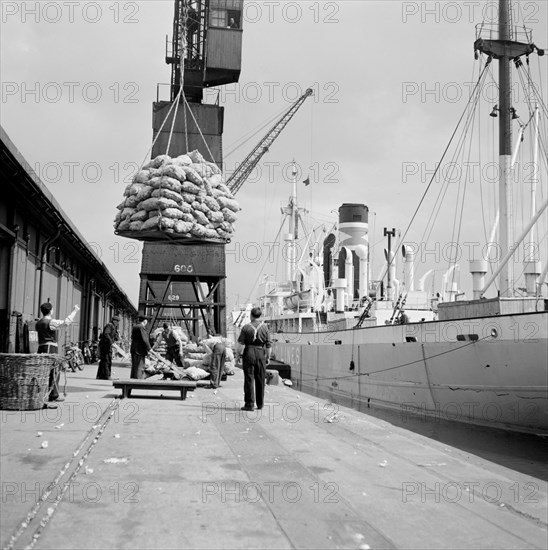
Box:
[0,0,548,310]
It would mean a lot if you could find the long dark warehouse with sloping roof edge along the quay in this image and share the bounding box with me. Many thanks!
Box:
[0,127,137,353]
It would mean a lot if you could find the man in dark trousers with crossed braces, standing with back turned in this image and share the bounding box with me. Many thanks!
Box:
[236,307,272,411]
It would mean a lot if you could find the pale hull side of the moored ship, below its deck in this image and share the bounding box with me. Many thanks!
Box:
[273,312,548,434]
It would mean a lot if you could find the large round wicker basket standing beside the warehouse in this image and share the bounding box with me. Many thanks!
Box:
[0,353,63,411]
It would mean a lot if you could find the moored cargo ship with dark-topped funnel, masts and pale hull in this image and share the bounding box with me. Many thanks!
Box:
[233,1,548,440]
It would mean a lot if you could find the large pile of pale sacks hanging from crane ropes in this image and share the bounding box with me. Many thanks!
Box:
[114,151,241,241]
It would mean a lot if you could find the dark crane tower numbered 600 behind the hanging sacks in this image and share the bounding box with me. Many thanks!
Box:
[139,0,243,336]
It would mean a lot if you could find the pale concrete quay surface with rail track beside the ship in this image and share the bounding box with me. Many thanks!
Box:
[0,364,548,549]
